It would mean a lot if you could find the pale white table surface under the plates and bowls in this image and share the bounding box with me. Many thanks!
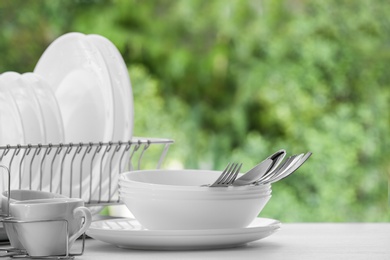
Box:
[64,223,390,260]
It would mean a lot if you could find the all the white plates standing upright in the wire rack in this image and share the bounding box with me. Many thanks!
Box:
[0,33,133,204]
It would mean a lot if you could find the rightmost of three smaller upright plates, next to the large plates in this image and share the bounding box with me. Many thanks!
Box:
[21,72,64,191]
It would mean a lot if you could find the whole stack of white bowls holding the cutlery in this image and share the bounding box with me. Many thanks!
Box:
[119,170,271,230]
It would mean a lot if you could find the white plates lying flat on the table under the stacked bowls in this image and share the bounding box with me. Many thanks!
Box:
[87,218,281,250]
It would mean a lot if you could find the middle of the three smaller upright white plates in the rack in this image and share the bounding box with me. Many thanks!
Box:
[4,72,46,189]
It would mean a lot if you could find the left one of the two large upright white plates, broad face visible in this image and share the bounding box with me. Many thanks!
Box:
[34,33,114,200]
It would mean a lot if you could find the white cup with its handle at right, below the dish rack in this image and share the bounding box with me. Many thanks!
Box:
[9,198,92,257]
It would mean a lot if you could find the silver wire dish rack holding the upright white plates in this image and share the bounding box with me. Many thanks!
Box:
[0,137,174,206]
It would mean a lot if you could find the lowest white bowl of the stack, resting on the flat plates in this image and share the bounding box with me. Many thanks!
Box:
[120,192,271,230]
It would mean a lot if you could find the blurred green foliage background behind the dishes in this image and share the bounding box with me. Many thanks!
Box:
[0,0,390,222]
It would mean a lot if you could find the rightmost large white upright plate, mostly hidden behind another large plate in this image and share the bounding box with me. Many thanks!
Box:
[87,34,134,201]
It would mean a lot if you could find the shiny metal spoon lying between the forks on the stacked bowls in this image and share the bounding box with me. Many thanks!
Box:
[232,150,286,186]
